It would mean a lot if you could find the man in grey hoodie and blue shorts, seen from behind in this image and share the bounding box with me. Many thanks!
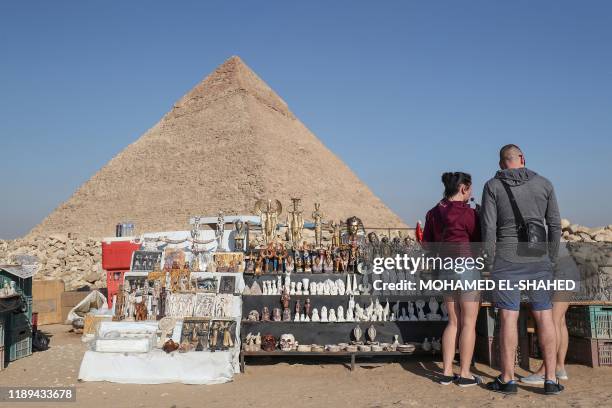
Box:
[480,145,563,394]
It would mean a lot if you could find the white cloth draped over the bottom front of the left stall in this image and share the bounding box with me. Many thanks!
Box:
[79,350,234,384]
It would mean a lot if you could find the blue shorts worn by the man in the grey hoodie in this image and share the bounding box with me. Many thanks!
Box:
[491,257,553,311]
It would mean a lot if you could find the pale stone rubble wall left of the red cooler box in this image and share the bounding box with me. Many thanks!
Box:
[0,234,106,290]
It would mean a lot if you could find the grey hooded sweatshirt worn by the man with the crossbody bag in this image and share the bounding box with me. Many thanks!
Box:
[480,168,561,262]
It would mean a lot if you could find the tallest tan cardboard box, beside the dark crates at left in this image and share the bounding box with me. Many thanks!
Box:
[32,279,64,326]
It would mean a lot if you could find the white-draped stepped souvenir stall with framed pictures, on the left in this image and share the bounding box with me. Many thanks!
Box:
[79,215,244,384]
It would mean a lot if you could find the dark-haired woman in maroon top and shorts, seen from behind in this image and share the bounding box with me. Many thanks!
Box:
[423,172,481,387]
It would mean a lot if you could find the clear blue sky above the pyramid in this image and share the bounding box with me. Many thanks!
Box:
[0,0,612,238]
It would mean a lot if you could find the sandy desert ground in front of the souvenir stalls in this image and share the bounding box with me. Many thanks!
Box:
[0,325,612,408]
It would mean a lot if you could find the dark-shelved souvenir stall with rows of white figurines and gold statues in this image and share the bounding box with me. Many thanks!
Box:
[241,199,447,370]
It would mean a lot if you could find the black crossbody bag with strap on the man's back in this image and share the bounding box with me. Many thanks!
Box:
[501,181,548,257]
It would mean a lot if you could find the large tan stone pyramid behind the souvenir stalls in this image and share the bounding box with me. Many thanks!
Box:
[30,57,405,238]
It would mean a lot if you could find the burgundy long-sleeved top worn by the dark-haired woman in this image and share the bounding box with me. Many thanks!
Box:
[423,198,480,242]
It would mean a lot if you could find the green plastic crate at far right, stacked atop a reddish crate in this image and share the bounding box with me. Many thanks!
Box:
[565,306,612,339]
